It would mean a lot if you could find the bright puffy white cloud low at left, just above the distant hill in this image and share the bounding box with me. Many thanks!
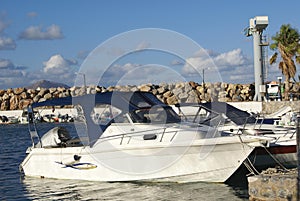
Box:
[43,54,77,75]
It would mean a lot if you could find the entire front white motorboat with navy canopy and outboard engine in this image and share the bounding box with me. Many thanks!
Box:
[20,92,268,182]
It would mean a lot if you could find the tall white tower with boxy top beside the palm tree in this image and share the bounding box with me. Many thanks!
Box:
[244,16,269,101]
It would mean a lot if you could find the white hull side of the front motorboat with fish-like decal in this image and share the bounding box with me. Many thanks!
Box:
[20,136,254,182]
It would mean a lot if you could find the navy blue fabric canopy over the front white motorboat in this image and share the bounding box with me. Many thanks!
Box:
[28,91,173,146]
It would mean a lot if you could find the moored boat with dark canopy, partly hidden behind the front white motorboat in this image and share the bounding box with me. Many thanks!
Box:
[174,102,297,170]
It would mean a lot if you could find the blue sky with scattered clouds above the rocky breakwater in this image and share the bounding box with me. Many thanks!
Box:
[0,0,300,89]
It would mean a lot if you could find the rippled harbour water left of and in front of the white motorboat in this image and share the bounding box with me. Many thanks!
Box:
[0,124,248,201]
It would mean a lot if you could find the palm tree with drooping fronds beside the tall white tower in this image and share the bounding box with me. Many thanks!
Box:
[270,24,300,99]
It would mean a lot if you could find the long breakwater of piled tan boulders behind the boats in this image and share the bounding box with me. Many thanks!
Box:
[0,82,255,110]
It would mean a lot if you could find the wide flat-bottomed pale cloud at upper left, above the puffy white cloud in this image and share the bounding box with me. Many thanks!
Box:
[19,24,64,40]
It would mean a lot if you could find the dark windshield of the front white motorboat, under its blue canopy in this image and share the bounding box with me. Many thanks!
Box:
[130,105,181,124]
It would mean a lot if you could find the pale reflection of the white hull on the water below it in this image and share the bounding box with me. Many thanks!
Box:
[22,177,248,201]
